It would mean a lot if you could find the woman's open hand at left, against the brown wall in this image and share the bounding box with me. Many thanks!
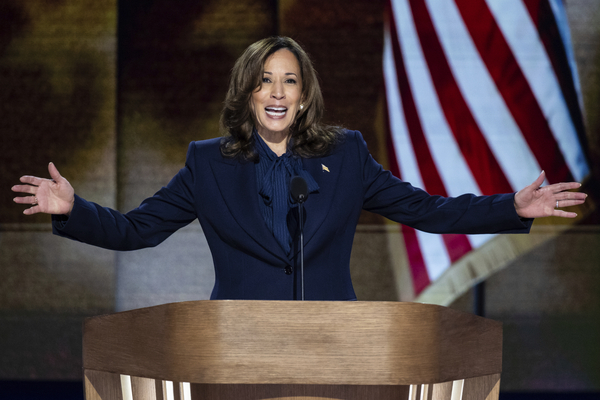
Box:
[11,163,75,215]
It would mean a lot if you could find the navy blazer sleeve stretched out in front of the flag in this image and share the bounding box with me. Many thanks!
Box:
[356,132,533,234]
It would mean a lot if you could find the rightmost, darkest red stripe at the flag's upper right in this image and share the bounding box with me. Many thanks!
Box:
[524,0,587,159]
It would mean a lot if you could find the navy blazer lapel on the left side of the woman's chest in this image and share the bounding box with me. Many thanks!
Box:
[210,158,288,261]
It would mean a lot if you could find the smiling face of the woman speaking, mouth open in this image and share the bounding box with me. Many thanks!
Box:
[250,49,302,137]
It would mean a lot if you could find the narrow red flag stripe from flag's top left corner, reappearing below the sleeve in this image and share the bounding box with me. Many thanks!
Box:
[389,2,474,268]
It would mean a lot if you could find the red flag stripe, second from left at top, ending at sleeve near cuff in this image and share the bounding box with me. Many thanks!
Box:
[410,0,513,195]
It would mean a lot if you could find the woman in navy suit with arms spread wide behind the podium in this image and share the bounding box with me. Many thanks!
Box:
[12,37,586,300]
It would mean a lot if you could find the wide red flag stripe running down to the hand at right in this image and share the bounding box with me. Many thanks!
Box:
[456,0,573,182]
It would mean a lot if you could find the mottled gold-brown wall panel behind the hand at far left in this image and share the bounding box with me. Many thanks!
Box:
[0,0,116,379]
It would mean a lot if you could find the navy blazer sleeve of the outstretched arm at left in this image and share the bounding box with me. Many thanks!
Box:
[52,143,197,250]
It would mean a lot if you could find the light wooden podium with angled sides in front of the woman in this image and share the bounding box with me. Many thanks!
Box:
[83,300,502,400]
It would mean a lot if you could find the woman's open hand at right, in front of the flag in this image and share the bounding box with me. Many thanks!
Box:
[515,171,587,218]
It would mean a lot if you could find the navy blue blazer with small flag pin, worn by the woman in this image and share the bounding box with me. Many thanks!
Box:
[53,131,531,300]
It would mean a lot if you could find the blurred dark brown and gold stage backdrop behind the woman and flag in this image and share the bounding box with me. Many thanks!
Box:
[0,0,600,399]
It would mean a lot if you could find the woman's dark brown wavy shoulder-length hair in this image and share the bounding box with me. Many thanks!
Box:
[220,36,342,160]
